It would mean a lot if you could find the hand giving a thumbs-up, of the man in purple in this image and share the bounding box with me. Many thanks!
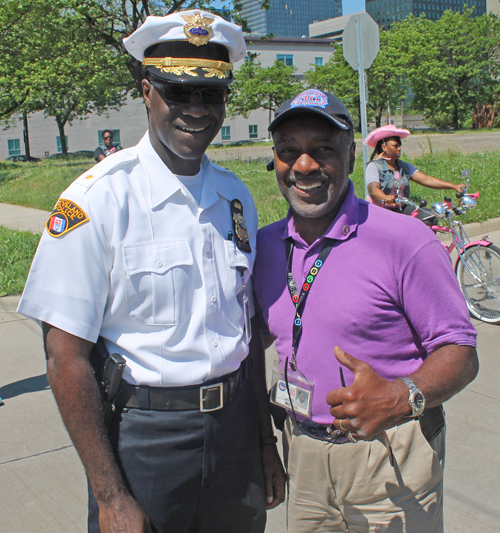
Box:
[326,346,411,440]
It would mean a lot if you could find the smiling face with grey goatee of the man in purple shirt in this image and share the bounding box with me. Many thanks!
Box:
[273,113,356,243]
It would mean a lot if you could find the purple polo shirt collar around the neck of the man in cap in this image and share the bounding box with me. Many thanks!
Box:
[282,180,359,245]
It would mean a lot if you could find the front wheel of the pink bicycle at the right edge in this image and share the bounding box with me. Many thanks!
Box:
[456,244,500,324]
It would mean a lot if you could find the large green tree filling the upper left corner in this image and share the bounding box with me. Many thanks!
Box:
[0,0,128,153]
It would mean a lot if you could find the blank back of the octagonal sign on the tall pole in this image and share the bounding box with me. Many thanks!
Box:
[342,11,380,70]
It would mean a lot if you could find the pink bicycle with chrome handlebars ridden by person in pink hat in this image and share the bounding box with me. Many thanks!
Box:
[395,170,500,324]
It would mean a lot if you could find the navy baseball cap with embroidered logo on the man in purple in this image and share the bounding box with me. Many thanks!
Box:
[267,89,354,133]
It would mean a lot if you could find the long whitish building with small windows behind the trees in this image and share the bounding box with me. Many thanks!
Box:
[0,35,334,159]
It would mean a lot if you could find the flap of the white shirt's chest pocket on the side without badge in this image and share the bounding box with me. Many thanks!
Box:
[123,239,193,276]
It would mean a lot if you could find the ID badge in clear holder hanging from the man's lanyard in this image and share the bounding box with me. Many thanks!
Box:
[271,359,314,418]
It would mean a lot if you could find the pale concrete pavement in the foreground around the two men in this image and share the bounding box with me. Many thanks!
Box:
[0,286,500,533]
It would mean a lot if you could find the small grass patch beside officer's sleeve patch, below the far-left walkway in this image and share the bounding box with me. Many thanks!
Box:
[0,226,40,296]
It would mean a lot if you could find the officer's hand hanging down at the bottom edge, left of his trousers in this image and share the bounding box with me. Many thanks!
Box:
[99,493,153,533]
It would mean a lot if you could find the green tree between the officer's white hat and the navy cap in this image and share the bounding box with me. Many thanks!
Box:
[228,54,303,133]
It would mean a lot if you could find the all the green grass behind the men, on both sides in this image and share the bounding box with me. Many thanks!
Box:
[0,151,500,296]
